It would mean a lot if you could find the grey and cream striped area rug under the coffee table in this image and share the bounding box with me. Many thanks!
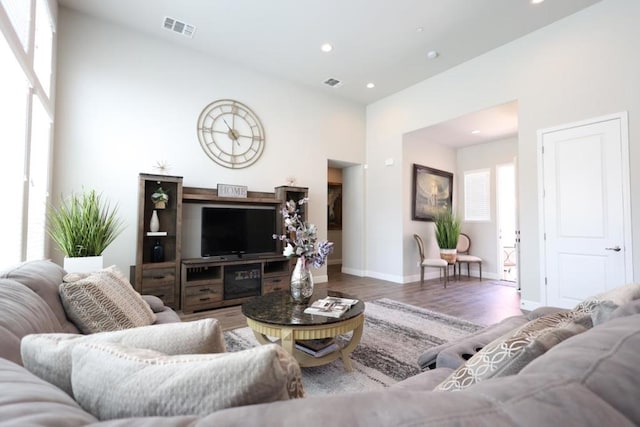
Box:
[225,298,483,395]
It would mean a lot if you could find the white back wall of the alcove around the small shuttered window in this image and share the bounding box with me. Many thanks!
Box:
[457,138,518,279]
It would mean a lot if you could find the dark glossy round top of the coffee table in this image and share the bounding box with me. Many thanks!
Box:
[242,290,364,326]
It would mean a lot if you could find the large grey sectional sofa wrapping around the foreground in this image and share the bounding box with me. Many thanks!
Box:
[0,261,640,427]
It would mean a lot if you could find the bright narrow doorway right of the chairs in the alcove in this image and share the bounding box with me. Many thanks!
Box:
[496,162,518,286]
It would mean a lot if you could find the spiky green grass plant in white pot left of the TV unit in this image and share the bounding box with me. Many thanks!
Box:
[47,190,123,272]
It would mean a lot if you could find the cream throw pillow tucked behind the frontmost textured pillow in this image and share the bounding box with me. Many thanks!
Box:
[21,319,225,395]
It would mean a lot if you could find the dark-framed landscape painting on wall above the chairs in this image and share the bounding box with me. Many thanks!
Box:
[411,164,453,221]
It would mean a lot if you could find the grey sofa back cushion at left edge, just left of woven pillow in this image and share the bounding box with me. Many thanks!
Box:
[0,279,62,365]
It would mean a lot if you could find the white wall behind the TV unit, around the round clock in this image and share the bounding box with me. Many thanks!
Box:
[51,8,365,281]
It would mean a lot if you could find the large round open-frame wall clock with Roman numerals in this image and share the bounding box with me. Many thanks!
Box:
[198,99,264,169]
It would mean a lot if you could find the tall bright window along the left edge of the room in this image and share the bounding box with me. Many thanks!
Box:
[0,0,54,267]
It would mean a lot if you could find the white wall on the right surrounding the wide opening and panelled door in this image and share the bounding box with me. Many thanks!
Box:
[366,0,640,303]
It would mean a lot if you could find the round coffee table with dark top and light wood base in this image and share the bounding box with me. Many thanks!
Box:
[242,291,364,371]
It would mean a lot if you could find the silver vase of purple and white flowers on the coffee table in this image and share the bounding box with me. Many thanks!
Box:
[273,198,333,304]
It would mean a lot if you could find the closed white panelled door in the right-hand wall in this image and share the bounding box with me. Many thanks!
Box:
[541,115,633,308]
